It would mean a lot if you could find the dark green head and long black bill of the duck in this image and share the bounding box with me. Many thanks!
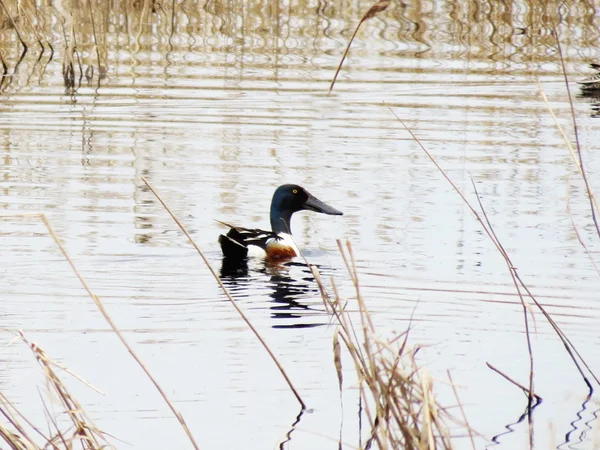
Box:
[271,184,343,234]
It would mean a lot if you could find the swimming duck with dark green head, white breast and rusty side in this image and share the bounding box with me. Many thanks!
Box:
[218,184,343,262]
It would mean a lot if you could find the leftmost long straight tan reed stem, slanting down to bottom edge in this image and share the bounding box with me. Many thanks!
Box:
[31,214,199,450]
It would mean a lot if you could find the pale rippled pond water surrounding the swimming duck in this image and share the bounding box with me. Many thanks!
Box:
[0,1,600,449]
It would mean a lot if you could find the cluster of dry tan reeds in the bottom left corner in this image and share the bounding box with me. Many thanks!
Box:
[0,333,113,450]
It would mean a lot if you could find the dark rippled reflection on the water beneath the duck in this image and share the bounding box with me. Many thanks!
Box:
[221,258,329,328]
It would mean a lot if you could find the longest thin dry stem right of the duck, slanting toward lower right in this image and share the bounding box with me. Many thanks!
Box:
[388,107,600,391]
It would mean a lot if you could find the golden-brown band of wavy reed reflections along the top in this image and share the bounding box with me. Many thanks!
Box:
[0,0,600,90]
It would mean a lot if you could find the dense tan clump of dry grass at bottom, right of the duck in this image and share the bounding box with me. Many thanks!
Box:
[311,241,454,450]
